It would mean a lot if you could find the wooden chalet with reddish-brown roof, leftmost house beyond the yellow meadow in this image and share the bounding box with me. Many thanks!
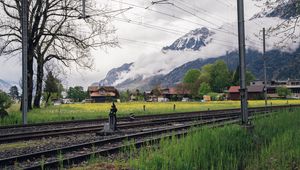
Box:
[88,85,119,103]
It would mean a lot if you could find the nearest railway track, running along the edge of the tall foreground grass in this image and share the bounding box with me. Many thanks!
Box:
[0,115,238,169]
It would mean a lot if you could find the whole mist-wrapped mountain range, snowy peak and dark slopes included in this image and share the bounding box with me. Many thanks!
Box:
[100,1,300,90]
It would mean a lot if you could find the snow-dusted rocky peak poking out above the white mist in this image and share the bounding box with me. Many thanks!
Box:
[163,27,214,50]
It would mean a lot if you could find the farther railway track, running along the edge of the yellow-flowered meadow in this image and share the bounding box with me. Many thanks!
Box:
[0,105,299,144]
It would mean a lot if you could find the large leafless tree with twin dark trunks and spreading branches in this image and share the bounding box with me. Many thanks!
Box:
[0,0,117,108]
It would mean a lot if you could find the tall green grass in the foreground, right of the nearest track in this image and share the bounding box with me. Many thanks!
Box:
[128,110,300,170]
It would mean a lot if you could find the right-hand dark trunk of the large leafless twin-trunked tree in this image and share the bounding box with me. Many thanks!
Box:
[33,56,44,108]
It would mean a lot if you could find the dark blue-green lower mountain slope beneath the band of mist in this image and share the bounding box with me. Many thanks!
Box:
[156,48,300,87]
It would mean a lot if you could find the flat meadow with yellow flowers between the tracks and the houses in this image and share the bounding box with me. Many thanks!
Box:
[0,100,300,126]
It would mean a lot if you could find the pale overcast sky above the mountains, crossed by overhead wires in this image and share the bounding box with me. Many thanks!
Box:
[0,0,268,87]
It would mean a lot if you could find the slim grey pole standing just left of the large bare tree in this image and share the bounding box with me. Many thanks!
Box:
[21,0,28,125]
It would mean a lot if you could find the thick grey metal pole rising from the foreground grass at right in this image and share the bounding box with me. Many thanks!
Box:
[237,0,249,125]
